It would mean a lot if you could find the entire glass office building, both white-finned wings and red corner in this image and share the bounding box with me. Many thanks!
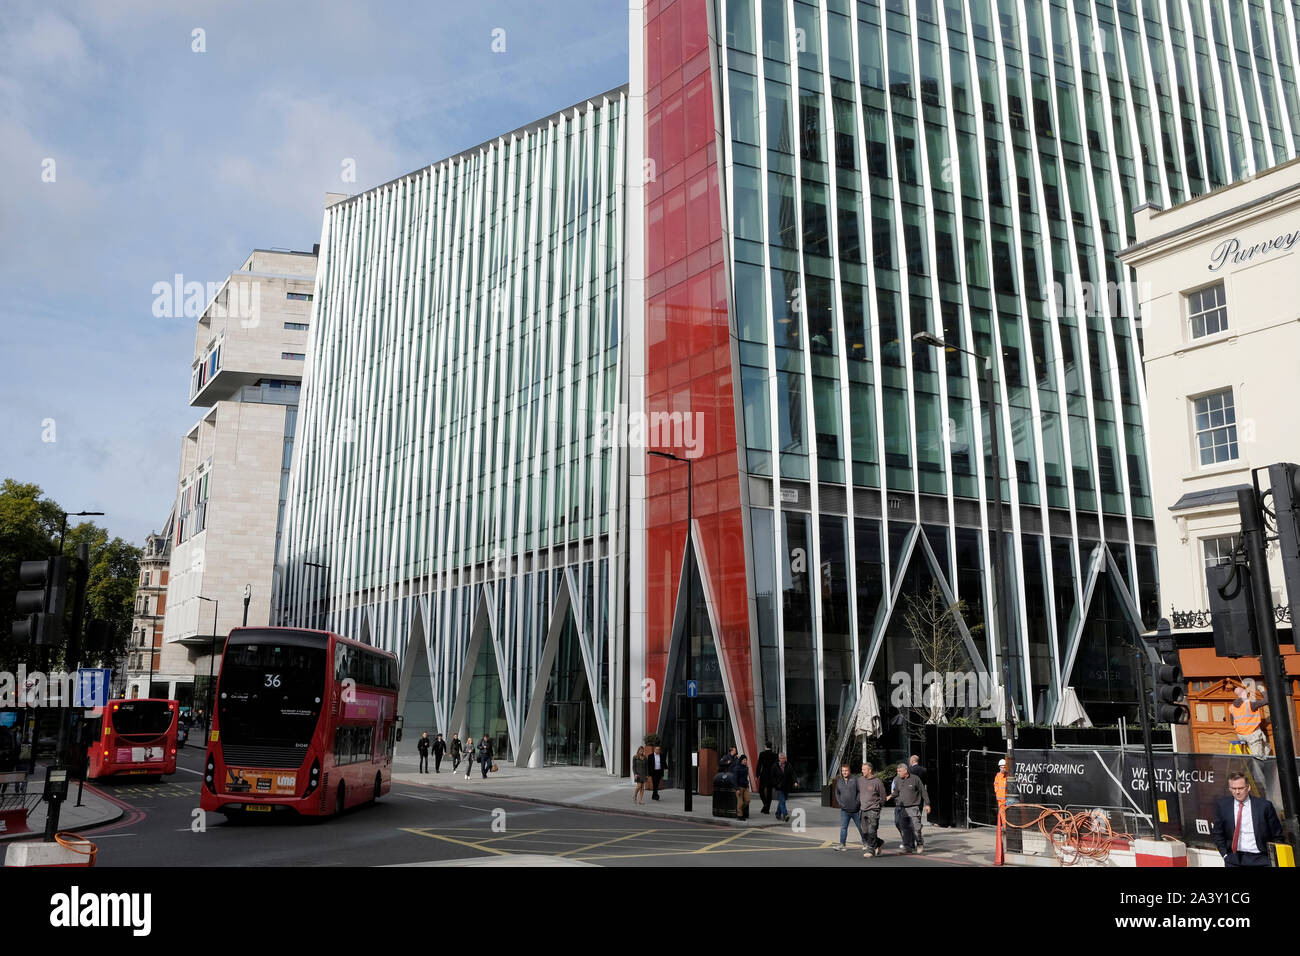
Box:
[281,0,1300,787]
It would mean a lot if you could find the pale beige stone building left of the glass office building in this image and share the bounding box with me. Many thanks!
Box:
[164,250,316,706]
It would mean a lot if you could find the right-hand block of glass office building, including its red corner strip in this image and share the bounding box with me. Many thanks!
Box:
[629,0,1300,786]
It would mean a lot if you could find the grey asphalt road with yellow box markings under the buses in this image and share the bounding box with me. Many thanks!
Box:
[76,748,961,869]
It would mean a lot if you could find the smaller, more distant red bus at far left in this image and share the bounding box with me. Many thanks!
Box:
[82,697,179,780]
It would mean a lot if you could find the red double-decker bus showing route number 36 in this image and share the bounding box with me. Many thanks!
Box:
[199,627,398,817]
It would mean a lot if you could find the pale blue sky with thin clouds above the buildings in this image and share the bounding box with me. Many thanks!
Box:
[0,0,628,545]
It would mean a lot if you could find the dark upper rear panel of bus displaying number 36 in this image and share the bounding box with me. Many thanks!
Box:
[217,643,325,747]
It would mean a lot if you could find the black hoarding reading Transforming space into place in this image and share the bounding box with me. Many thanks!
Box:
[1015,750,1282,847]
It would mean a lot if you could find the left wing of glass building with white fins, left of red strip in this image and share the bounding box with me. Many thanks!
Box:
[278,90,627,765]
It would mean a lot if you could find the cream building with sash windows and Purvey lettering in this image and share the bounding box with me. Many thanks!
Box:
[1123,160,1300,617]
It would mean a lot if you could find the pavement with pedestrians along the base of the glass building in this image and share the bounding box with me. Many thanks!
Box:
[393,754,995,866]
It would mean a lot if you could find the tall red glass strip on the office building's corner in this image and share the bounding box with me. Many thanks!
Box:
[645,0,757,753]
